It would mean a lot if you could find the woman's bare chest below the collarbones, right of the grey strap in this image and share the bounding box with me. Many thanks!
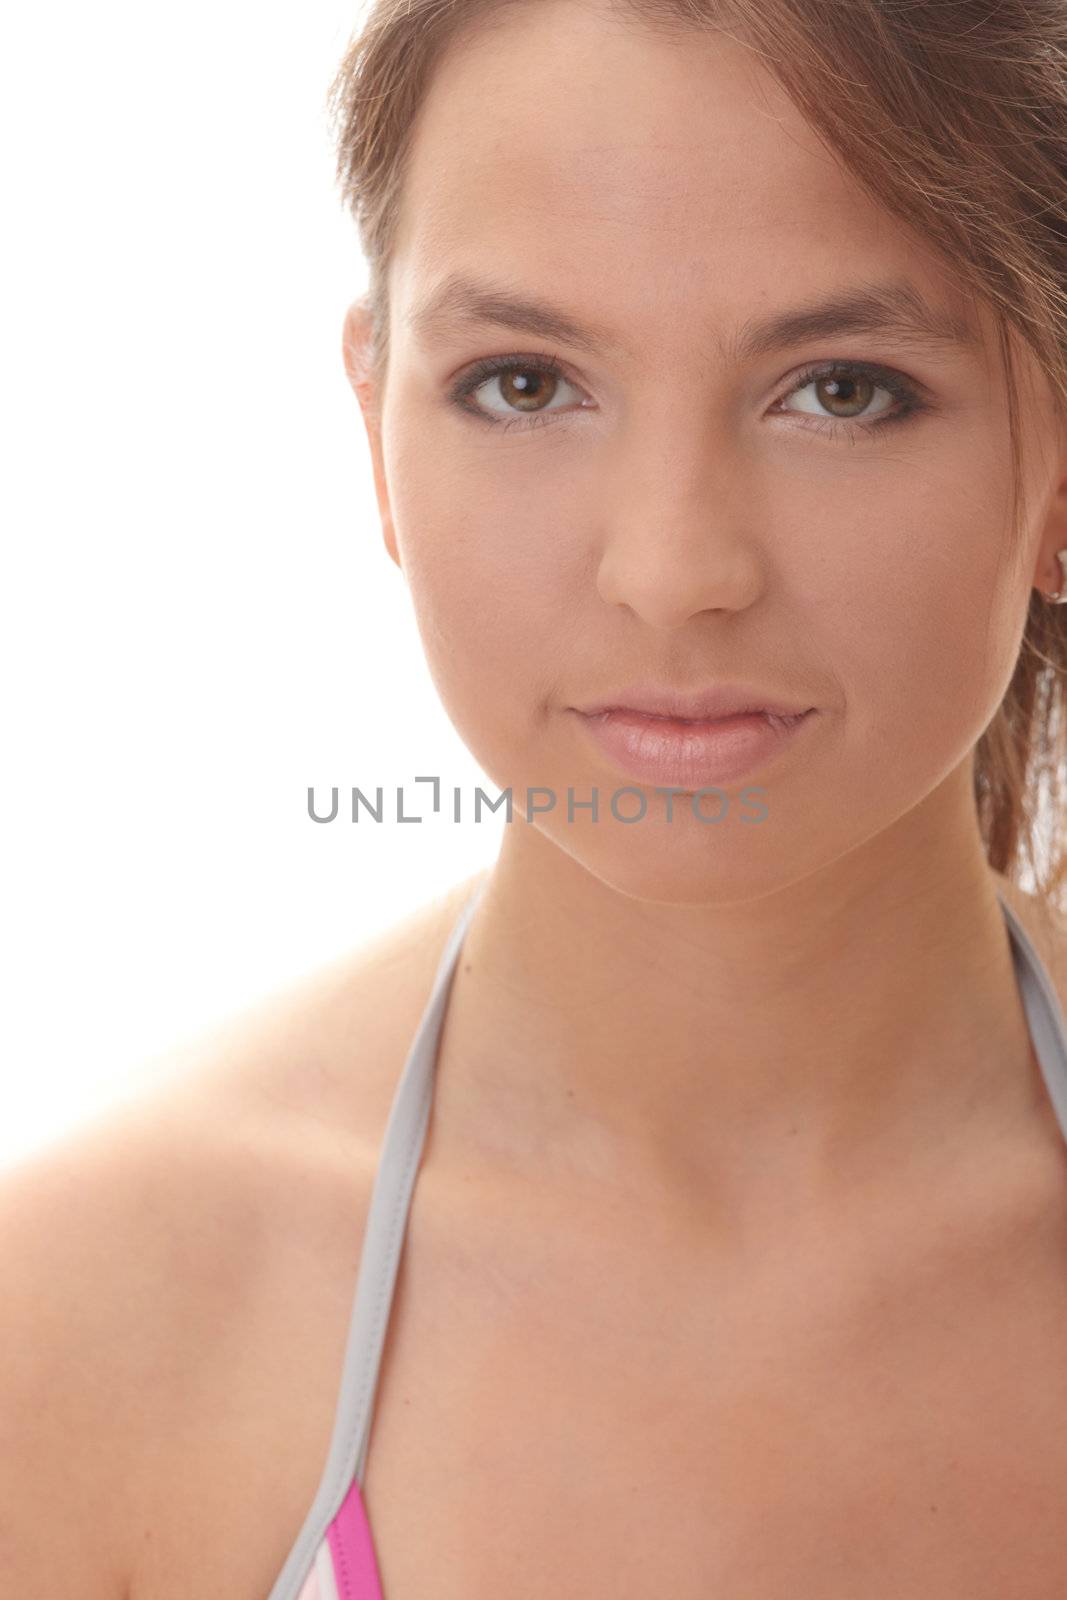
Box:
[355,1203,1067,1600]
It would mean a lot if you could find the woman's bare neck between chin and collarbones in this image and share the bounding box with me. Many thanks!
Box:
[438,796,1043,1200]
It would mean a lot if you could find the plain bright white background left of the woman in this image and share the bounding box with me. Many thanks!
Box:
[0,0,502,1163]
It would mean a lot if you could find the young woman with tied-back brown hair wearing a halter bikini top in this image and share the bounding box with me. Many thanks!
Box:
[0,0,1067,1600]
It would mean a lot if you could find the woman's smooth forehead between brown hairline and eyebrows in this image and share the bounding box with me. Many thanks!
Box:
[390,0,974,353]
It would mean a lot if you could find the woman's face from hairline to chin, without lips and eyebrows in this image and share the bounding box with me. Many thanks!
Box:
[347,0,1067,901]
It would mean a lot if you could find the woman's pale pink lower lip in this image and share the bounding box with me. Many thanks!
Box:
[574,707,817,790]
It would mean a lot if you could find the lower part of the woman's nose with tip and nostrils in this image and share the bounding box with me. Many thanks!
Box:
[597,457,763,629]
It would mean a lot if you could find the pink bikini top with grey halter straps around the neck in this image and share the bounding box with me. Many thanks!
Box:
[267,888,1067,1600]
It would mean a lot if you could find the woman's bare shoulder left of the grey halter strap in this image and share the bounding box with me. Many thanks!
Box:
[0,878,489,1600]
